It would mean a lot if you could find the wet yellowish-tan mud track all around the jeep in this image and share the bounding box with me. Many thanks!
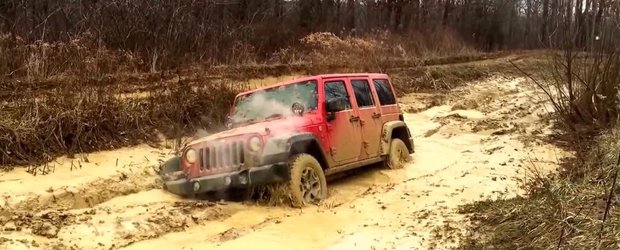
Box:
[0,77,567,249]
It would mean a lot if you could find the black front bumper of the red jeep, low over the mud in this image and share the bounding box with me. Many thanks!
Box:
[164,162,290,196]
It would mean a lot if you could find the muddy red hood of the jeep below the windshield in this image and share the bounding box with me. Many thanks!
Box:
[188,115,317,146]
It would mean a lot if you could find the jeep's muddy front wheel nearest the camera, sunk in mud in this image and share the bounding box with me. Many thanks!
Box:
[287,154,327,207]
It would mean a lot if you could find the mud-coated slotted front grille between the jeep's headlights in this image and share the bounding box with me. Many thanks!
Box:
[198,141,244,170]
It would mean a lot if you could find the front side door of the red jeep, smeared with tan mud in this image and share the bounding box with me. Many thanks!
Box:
[323,79,362,165]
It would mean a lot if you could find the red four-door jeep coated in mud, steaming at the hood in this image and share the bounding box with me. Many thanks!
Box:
[162,74,414,206]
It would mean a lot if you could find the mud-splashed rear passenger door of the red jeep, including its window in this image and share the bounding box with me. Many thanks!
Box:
[351,79,382,158]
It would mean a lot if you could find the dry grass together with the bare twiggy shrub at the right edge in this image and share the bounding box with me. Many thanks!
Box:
[462,50,620,249]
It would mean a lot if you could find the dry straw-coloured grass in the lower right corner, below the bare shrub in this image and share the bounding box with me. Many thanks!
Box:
[462,127,620,249]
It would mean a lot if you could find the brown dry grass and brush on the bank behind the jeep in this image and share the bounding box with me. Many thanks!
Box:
[0,30,498,169]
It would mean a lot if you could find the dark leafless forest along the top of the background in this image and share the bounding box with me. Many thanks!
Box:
[0,0,620,73]
